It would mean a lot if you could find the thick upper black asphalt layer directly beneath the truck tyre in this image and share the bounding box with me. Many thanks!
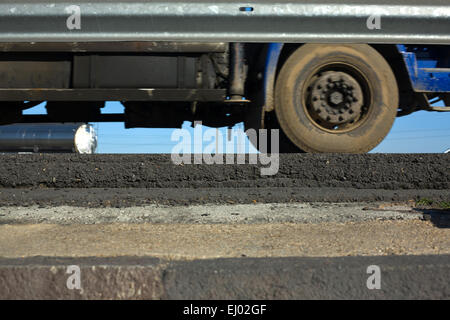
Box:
[0,154,450,190]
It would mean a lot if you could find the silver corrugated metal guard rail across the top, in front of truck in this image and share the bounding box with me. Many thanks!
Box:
[0,0,450,44]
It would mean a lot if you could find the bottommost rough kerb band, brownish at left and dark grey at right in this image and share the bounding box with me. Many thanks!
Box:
[0,255,450,300]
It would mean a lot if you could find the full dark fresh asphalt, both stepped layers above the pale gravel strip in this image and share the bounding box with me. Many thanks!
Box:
[0,154,450,207]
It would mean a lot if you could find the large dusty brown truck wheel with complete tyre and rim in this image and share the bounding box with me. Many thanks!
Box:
[275,44,399,153]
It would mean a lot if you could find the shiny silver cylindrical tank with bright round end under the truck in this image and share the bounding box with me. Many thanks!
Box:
[0,123,97,154]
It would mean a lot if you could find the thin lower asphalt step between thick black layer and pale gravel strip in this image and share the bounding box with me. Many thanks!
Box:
[0,187,450,208]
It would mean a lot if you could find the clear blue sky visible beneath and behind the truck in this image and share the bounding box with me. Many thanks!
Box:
[24,102,450,153]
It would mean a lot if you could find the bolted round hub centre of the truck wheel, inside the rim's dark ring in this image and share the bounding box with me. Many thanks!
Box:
[310,71,364,125]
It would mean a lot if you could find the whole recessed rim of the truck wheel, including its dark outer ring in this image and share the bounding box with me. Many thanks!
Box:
[301,63,373,134]
